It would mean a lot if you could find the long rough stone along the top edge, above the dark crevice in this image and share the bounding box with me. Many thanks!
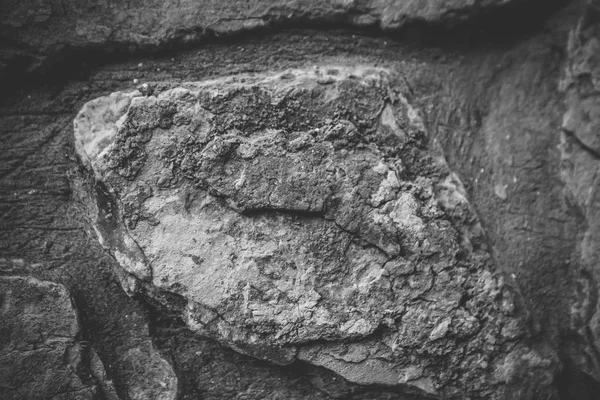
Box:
[0,0,531,73]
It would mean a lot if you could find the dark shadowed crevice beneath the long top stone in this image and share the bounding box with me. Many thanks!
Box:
[0,0,575,91]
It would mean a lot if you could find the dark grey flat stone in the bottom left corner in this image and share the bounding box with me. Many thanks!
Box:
[0,277,117,400]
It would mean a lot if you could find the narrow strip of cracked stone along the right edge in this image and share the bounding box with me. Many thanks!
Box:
[560,1,600,380]
